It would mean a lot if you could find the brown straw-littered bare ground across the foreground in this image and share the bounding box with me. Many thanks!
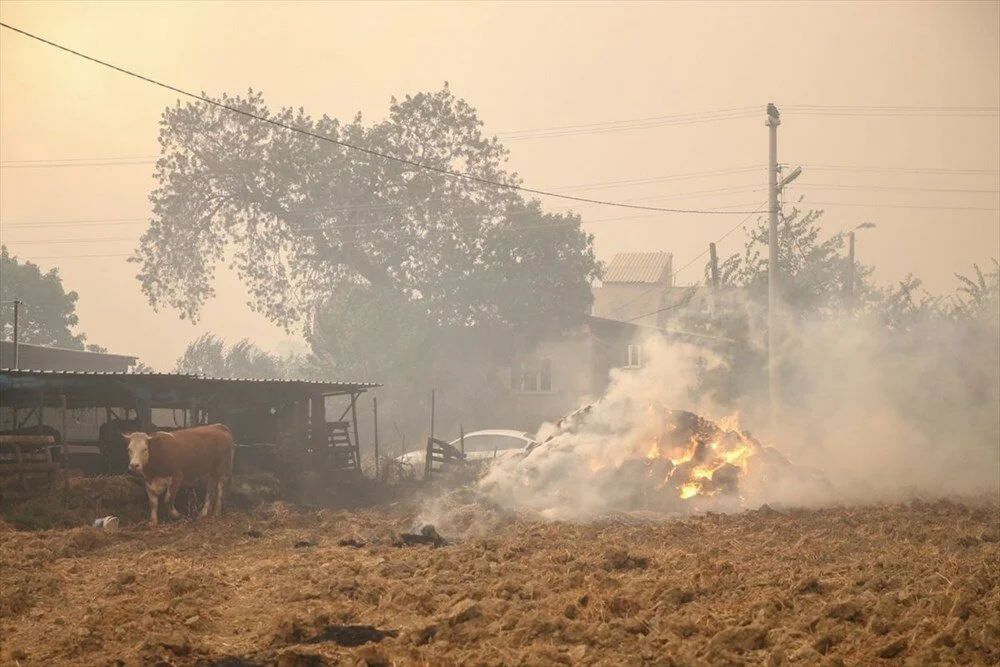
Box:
[0,494,1000,666]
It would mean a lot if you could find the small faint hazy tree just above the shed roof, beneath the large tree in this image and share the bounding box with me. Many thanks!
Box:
[174,334,286,379]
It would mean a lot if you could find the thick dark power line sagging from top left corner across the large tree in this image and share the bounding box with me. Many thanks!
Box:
[0,22,760,215]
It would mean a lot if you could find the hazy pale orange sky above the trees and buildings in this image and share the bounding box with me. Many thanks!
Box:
[0,0,1000,370]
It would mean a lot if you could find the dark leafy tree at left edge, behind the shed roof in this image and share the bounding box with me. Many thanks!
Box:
[0,246,96,351]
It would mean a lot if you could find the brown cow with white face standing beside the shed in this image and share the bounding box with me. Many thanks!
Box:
[122,424,235,526]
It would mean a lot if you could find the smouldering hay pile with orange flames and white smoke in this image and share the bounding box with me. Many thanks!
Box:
[480,399,830,519]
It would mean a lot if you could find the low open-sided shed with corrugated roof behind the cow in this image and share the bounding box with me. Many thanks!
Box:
[0,369,378,474]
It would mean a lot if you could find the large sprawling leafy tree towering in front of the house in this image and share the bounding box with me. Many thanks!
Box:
[132,84,600,438]
